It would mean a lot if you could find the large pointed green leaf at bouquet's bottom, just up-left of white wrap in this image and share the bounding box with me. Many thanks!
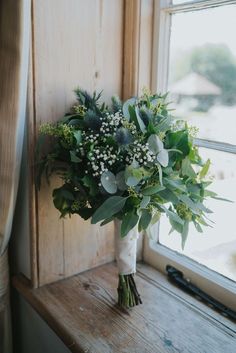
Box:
[91,196,128,224]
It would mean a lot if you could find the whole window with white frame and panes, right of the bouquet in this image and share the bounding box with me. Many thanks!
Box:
[145,0,236,309]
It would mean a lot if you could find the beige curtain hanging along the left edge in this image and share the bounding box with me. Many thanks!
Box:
[0,0,30,353]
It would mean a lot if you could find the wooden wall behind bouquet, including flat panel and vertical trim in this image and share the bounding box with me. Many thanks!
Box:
[28,0,153,286]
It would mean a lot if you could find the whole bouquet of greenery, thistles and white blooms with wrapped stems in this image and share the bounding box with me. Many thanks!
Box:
[37,89,217,307]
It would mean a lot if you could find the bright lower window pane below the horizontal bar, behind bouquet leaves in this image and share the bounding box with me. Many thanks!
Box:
[159,148,236,281]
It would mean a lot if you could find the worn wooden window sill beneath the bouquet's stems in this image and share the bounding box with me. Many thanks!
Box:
[13,263,236,353]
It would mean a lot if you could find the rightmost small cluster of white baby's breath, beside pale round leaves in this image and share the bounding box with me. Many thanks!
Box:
[126,141,156,166]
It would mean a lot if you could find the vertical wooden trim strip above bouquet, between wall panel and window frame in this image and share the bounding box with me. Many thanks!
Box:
[123,0,154,99]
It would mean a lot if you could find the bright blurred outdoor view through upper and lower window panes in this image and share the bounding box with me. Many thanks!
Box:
[159,0,236,281]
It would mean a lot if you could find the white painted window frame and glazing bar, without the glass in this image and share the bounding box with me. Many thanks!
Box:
[144,0,236,310]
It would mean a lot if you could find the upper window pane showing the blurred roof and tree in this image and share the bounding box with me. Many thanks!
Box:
[168,5,236,144]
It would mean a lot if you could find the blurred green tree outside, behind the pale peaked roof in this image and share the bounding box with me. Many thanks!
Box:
[170,44,236,106]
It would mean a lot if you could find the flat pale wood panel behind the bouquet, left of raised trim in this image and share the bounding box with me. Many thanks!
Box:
[33,0,123,285]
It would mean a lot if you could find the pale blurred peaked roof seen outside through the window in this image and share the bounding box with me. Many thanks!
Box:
[170,72,221,96]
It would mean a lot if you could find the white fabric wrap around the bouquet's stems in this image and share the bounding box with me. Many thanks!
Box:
[114,219,139,275]
